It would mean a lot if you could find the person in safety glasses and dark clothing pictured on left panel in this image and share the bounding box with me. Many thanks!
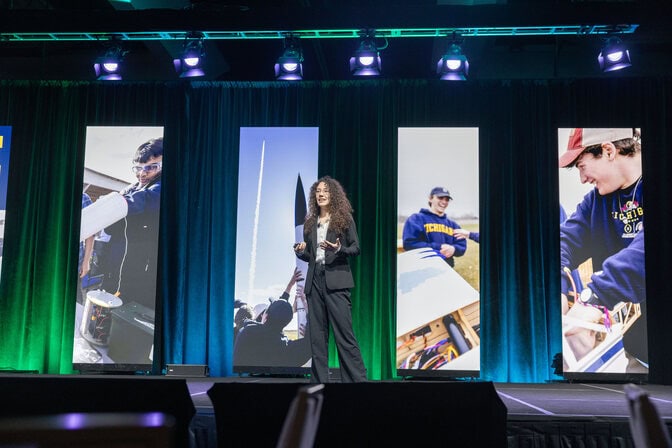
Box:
[99,137,163,311]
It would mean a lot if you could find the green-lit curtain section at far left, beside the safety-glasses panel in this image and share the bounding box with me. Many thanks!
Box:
[0,83,85,373]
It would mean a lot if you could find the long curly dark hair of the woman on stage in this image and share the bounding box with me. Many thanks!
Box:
[303,176,353,235]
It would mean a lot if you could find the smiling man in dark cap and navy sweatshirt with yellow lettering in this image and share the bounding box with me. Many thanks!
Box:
[402,187,467,267]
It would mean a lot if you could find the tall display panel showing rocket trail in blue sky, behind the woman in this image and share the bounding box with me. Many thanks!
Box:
[232,127,319,374]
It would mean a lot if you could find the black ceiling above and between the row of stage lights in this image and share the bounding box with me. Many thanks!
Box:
[0,0,672,81]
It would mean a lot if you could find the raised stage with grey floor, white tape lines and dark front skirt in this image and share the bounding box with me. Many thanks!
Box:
[188,377,672,448]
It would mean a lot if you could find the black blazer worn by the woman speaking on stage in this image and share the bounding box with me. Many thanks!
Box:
[296,220,359,294]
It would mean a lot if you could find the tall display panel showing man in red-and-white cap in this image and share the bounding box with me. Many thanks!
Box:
[558,128,648,380]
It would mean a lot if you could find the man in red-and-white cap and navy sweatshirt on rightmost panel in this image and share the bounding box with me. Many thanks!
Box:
[559,128,648,373]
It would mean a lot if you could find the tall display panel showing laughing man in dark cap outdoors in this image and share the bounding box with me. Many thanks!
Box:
[396,127,480,377]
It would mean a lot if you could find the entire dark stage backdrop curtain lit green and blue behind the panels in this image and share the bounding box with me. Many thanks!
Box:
[0,79,672,384]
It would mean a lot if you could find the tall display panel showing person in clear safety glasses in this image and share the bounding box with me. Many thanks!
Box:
[72,126,163,372]
